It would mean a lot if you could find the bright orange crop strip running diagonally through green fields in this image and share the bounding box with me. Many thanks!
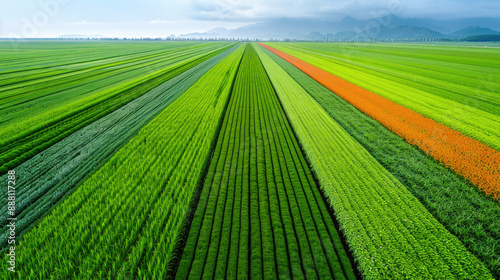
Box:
[259,43,500,200]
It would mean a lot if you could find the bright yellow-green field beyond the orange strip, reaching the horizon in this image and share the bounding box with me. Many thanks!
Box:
[269,43,500,151]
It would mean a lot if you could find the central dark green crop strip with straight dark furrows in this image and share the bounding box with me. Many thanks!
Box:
[176,45,356,279]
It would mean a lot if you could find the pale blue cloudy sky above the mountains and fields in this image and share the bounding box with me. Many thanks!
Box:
[0,0,500,37]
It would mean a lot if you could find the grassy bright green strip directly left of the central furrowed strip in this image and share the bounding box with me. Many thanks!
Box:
[1,44,243,279]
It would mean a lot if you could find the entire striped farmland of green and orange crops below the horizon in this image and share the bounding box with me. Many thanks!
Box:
[0,40,500,279]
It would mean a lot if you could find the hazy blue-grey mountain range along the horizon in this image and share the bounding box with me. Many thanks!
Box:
[178,14,500,40]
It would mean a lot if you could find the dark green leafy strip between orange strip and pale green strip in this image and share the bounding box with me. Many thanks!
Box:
[265,47,500,278]
